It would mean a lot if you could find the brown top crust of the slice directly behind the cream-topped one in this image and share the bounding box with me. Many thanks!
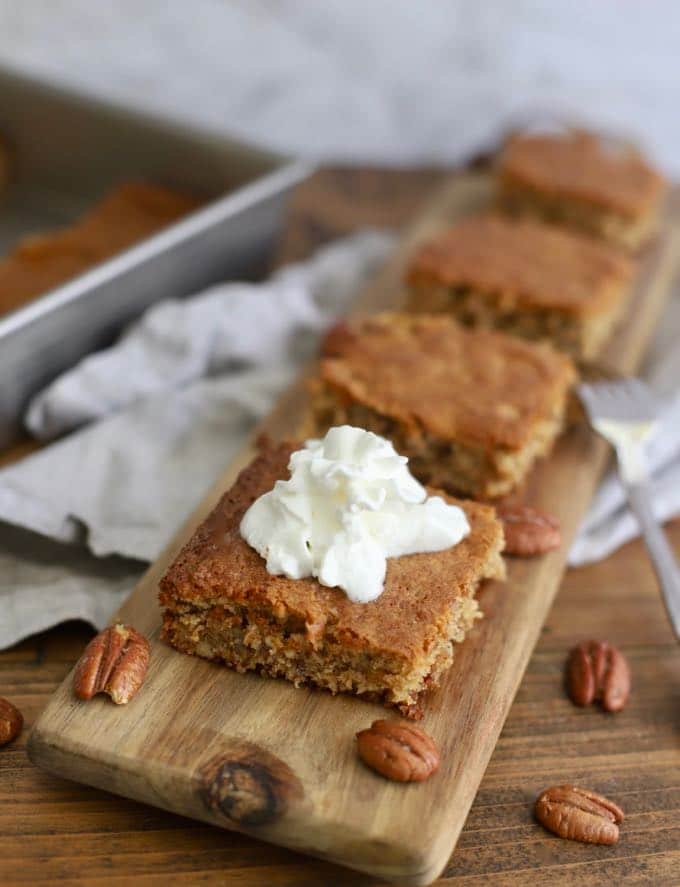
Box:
[320,314,574,449]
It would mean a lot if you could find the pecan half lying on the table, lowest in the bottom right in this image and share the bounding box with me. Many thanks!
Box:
[534,785,623,844]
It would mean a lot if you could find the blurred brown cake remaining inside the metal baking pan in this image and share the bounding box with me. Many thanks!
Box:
[0,182,199,315]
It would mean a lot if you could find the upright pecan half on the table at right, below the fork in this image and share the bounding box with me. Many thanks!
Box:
[567,641,630,712]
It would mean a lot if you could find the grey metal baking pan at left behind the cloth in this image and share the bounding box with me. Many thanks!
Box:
[0,68,311,446]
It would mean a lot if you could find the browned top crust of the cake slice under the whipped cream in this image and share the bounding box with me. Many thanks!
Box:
[160,444,502,658]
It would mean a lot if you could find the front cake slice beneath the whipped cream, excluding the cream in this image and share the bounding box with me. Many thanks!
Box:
[160,444,504,717]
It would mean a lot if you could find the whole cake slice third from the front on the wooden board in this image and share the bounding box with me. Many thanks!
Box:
[407,215,634,358]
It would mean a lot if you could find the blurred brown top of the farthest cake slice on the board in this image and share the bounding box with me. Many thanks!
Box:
[499,131,664,218]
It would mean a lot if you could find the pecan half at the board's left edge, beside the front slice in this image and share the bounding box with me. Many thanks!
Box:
[73,625,150,705]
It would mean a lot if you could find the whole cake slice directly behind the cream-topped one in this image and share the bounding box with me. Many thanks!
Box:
[311,314,574,497]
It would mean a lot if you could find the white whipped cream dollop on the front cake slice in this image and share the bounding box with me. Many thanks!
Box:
[241,425,470,603]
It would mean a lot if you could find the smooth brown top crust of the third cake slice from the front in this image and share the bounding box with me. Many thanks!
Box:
[407,215,633,315]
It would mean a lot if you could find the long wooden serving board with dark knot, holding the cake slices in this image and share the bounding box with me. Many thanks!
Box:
[29,175,680,884]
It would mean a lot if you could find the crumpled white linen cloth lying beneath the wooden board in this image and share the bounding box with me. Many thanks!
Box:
[0,231,680,648]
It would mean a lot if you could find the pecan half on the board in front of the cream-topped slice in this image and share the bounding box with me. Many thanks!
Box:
[357,720,439,782]
